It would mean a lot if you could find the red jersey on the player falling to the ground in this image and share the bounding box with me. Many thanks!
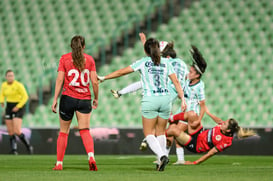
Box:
[196,125,233,153]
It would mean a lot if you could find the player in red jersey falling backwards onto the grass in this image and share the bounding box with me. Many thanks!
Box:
[167,108,255,165]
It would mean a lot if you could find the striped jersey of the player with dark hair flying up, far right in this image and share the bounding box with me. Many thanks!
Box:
[184,80,205,114]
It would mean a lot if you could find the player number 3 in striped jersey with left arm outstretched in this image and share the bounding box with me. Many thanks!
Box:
[98,38,185,171]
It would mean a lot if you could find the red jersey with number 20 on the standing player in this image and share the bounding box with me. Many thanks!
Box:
[58,52,96,100]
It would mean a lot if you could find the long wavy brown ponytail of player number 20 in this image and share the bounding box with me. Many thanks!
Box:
[70,35,85,71]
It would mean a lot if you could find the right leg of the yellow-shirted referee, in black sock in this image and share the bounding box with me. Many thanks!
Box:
[13,117,33,154]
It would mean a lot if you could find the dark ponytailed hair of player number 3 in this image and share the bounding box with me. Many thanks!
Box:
[144,38,160,65]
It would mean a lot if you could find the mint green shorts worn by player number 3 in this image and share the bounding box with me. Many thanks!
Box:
[141,95,172,119]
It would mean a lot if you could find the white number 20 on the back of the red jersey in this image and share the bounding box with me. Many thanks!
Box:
[68,69,89,86]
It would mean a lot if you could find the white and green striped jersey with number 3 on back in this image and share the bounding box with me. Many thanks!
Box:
[130,57,175,96]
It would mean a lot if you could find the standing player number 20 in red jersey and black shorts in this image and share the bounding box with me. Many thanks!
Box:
[51,36,99,171]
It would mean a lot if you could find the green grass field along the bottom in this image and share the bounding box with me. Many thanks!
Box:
[0,155,273,181]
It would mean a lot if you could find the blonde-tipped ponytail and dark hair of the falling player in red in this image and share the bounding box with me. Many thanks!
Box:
[228,118,257,138]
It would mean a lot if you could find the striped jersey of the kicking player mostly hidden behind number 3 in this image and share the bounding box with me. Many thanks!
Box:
[169,58,189,90]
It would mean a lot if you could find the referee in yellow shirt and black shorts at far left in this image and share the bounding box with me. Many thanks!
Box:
[0,70,33,155]
